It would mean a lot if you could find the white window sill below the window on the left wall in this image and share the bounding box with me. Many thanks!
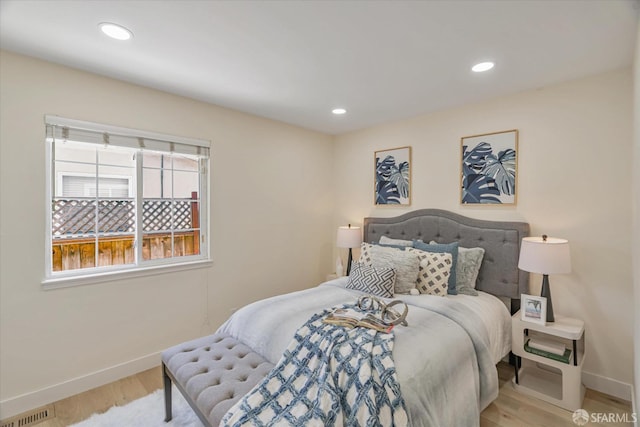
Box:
[42,260,213,290]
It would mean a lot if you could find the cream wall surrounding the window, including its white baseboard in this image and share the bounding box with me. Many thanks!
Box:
[0,52,335,419]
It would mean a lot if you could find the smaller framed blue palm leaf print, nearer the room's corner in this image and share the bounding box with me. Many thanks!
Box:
[374,147,411,206]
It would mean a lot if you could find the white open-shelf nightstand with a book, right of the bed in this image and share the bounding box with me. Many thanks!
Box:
[511,311,585,411]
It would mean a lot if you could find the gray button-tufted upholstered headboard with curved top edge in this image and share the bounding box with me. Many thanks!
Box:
[364,209,529,311]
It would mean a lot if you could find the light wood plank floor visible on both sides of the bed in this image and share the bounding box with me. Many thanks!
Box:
[3,362,631,427]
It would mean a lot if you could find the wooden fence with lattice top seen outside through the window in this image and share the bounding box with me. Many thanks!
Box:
[51,191,200,271]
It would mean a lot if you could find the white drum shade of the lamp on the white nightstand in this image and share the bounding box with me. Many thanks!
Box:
[518,237,571,274]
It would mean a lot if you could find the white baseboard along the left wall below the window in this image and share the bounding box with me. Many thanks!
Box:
[0,352,160,419]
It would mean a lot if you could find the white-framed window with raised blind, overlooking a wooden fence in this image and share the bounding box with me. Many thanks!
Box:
[45,116,209,282]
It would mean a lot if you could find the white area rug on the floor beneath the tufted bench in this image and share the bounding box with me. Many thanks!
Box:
[73,387,203,427]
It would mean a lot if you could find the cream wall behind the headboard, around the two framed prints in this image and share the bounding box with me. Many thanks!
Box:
[335,69,634,399]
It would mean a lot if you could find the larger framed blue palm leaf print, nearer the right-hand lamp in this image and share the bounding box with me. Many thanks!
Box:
[460,129,518,205]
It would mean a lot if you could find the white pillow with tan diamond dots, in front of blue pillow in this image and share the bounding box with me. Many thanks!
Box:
[409,249,453,296]
